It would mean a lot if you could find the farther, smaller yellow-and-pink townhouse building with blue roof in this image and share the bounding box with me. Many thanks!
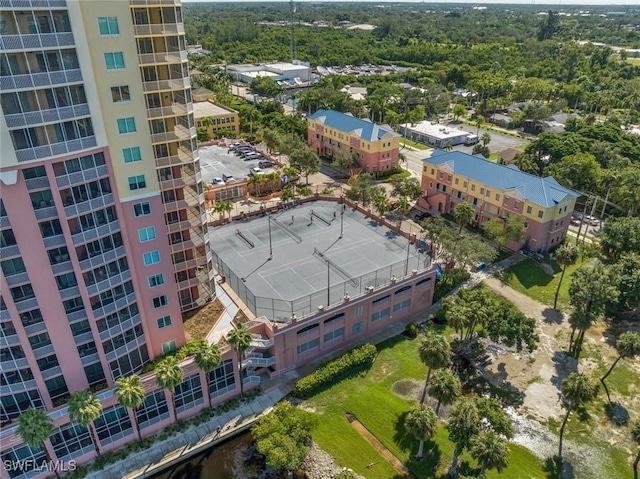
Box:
[307,110,400,174]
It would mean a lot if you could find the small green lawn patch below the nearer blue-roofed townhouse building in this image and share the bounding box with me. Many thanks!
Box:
[501,258,583,309]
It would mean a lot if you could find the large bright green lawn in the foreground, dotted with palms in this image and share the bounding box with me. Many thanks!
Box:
[305,337,545,479]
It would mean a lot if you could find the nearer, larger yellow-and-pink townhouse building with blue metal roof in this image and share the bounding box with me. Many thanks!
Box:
[420,150,579,252]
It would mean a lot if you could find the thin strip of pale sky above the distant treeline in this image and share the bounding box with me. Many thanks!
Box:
[182,0,639,5]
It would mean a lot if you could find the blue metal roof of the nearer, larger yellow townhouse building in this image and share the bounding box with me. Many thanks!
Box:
[422,150,580,208]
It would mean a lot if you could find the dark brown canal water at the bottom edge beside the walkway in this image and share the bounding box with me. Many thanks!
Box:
[153,432,258,479]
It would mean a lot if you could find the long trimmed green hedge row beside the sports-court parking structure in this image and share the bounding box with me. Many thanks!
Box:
[291,343,377,399]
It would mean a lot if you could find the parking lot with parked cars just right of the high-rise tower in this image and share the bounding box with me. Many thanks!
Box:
[199,146,274,184]
